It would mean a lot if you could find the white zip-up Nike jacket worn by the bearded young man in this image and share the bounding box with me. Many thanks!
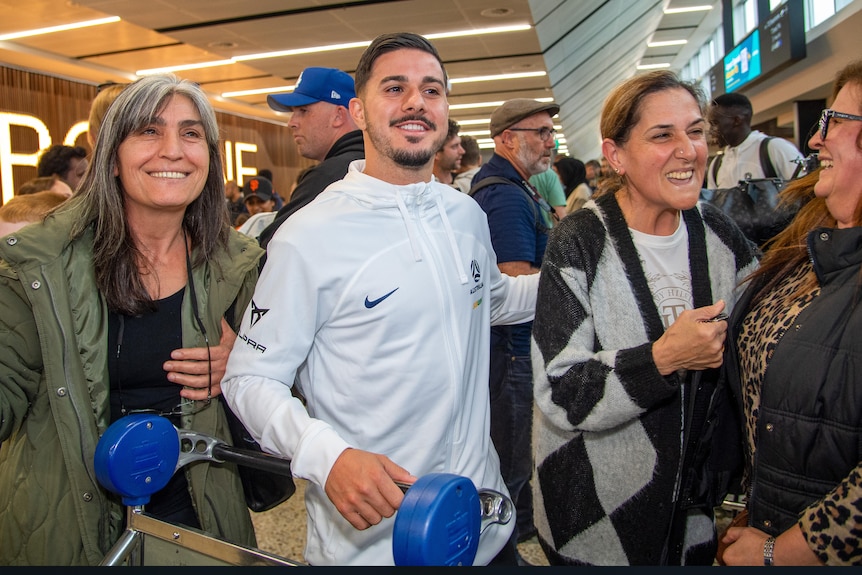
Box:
[222,160,538,565]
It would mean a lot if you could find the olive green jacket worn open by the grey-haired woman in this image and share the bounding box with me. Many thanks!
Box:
[0,205,263,565]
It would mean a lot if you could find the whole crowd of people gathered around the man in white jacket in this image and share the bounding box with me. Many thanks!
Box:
[0,25,862,566]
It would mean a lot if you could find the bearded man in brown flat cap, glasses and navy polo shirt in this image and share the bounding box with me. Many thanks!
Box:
[470,98,560,560]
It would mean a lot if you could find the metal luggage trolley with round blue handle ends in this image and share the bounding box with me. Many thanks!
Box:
[95,413,514,566]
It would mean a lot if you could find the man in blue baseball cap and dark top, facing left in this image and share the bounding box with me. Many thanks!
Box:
[258,67,365,253]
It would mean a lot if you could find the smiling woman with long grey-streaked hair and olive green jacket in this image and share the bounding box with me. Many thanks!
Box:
[0,75,262,565]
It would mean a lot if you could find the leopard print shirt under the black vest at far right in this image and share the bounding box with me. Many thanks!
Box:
[738,262,862,565]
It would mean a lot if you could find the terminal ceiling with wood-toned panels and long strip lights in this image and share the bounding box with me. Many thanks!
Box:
[0,0,862,159]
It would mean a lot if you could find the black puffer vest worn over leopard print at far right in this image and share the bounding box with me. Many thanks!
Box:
[727,228,862,560]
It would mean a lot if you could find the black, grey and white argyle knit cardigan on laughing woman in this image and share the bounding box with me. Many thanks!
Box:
[532,194,757,565]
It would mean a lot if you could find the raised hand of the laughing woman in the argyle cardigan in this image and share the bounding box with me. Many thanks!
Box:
[652,300,727,375]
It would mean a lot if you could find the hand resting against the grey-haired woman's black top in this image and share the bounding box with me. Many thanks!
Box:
[163,318,236,400]
